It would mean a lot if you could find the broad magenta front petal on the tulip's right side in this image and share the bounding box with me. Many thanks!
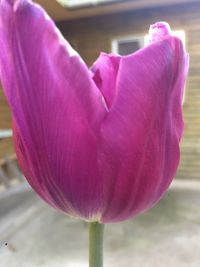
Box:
[101,26,188,223]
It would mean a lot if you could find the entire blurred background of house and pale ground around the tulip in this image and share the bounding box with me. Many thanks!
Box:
[0,0,200,267]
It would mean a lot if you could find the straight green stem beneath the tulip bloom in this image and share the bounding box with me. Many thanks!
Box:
[89,222,104,267]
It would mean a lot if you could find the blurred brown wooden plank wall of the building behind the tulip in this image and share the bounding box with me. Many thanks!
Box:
[0,1,200,179]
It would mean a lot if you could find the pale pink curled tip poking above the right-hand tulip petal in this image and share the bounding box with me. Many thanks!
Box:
[149,22,172,43]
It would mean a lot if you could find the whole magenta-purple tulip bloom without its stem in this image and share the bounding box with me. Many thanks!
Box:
[0,0,188,223]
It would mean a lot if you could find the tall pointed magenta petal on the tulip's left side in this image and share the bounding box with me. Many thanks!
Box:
[0,0,106,219]
